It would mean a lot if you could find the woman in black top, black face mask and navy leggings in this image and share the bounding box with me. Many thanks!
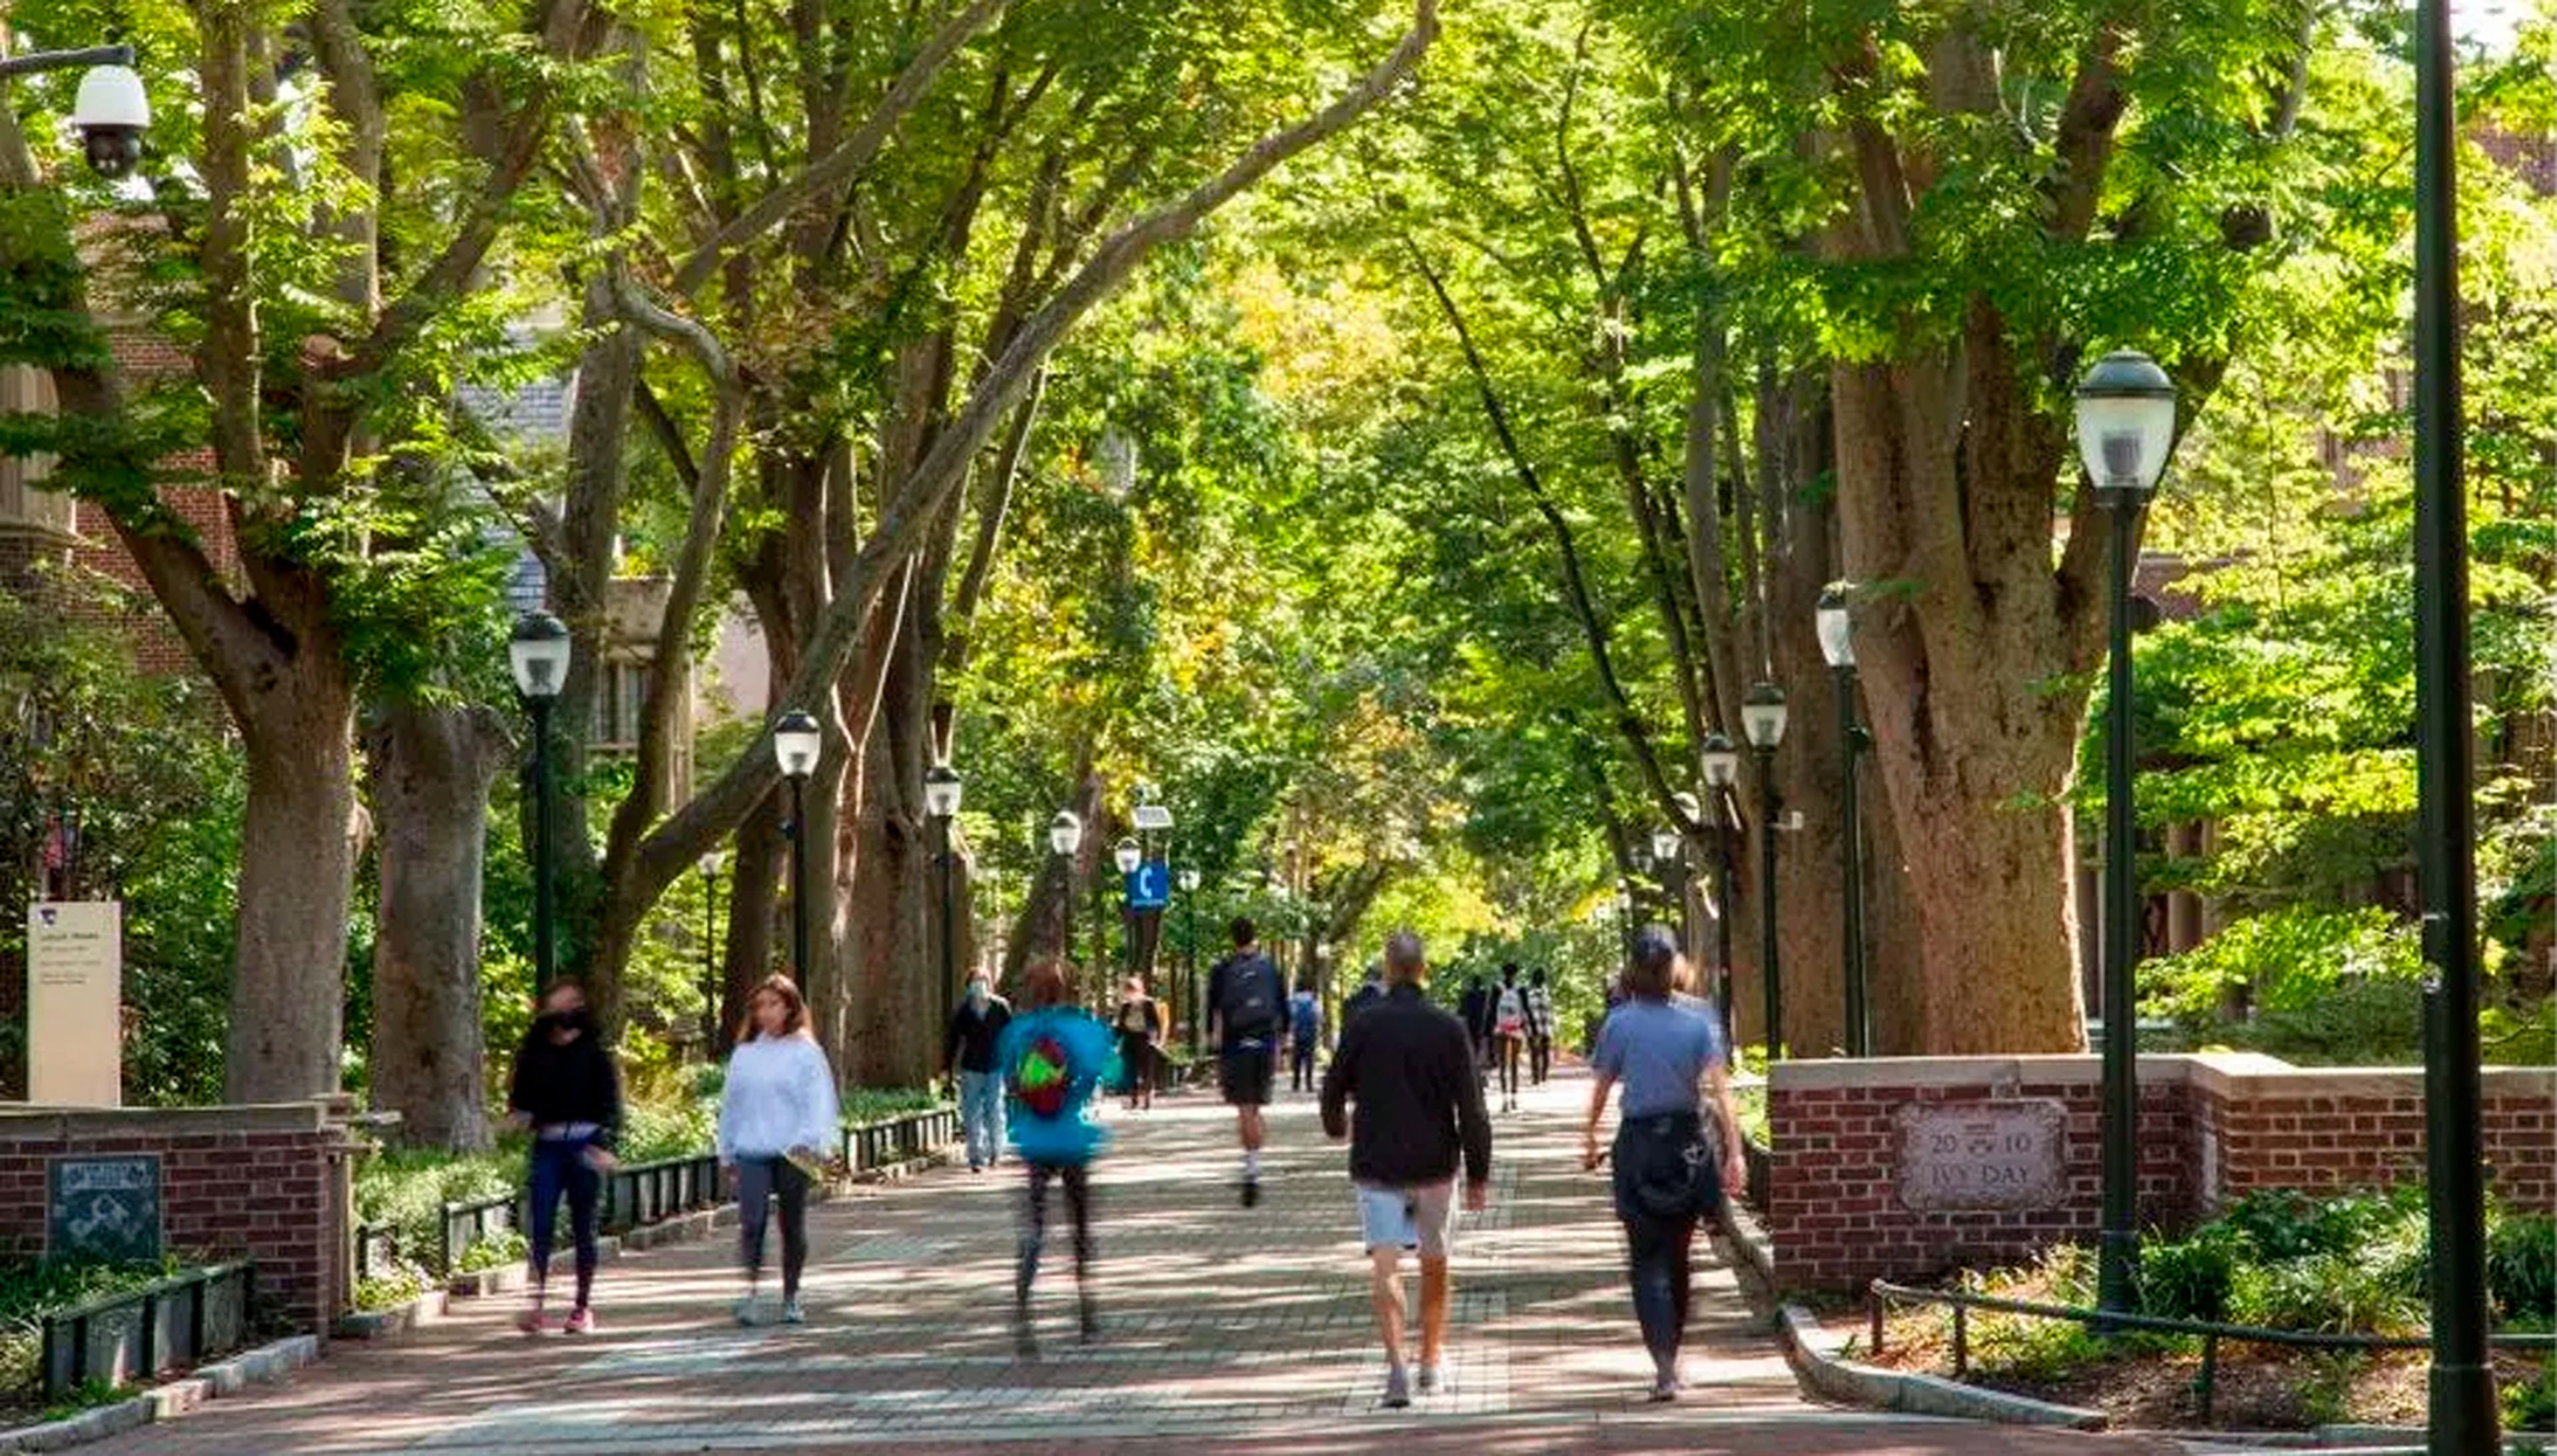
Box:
[506,981,621,1334]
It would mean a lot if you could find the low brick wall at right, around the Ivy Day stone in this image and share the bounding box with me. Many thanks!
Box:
[1767,1053,2557,1290]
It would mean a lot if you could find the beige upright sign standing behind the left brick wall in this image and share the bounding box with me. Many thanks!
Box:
[25,899,125,1106]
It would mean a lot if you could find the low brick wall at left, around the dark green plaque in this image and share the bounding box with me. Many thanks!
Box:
[0,1104,350,1334]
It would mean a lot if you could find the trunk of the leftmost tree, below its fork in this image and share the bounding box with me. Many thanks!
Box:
[222,658,356,1104]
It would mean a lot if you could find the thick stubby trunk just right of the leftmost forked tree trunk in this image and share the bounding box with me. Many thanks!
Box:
[368,702,506,1152]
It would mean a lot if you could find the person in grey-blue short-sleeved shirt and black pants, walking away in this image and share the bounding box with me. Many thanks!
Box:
[1580,925,1749,1400]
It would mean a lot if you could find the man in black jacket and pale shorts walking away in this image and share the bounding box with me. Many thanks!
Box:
[1322,930,1491,1407]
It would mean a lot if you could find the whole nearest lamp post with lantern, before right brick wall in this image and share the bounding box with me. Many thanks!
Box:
[2076,350,2176,1313]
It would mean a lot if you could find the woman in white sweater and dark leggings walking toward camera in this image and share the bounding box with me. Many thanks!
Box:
[718,976,839,1326]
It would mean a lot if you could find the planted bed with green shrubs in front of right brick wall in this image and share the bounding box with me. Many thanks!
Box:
[1859,1190,2557,1431]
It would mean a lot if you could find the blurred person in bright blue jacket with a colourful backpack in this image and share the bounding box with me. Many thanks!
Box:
[995,961,1110,1356]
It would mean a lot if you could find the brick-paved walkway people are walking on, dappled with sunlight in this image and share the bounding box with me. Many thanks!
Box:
[89,1057,2173,1456]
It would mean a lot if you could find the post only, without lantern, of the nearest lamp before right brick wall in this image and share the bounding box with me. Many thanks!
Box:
[2097,488,2140,1313]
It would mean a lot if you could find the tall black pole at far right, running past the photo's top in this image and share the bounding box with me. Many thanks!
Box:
[2414,0,2501,1430]
